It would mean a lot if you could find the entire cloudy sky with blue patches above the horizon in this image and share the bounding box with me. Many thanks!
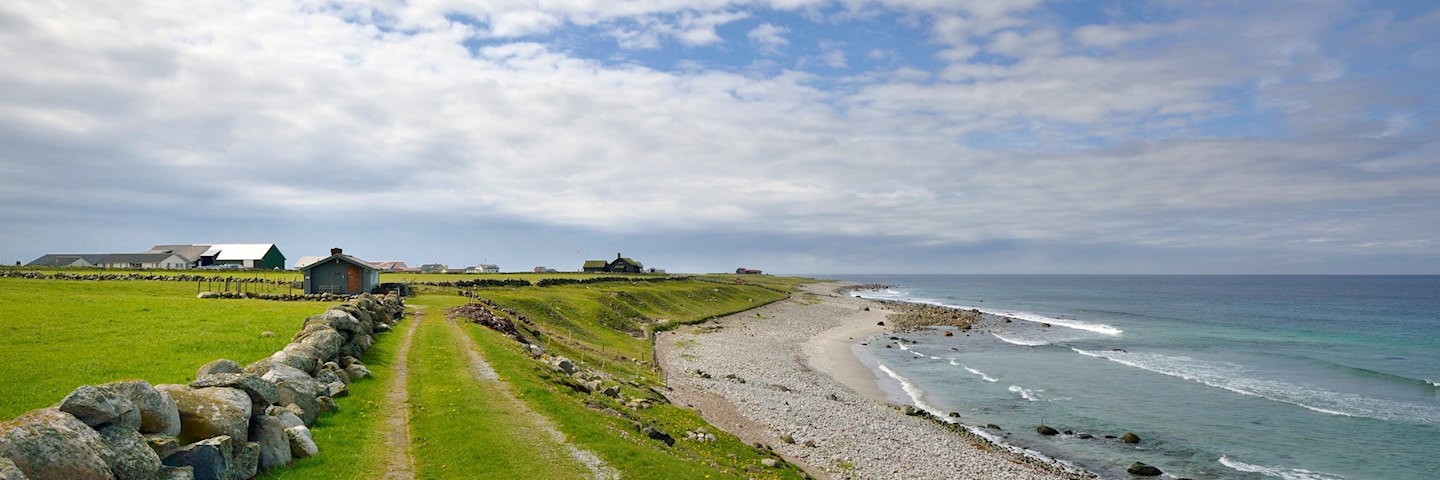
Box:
[0,0,1440,274]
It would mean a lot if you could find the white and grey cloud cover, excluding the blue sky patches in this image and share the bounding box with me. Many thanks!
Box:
[0,0,1440,272]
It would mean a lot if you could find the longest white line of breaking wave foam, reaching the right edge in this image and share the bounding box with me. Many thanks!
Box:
[1070,347,1440,424]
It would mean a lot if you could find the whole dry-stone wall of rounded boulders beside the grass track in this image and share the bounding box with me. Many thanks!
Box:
[0,294,405,480]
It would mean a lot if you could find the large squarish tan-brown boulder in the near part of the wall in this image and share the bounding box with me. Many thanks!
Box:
[156,385,252,455]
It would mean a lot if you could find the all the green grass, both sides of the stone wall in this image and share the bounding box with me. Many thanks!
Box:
[0,272,829,480]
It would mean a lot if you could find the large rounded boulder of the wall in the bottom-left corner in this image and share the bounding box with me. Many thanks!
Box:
[0,408,115,480]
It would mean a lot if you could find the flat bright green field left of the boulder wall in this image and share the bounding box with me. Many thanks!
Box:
[0,278,324,419]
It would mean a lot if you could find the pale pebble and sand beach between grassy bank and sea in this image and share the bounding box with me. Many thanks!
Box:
[657,283,1074,480]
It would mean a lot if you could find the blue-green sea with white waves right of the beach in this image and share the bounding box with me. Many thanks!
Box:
[840,275,1440,480]
